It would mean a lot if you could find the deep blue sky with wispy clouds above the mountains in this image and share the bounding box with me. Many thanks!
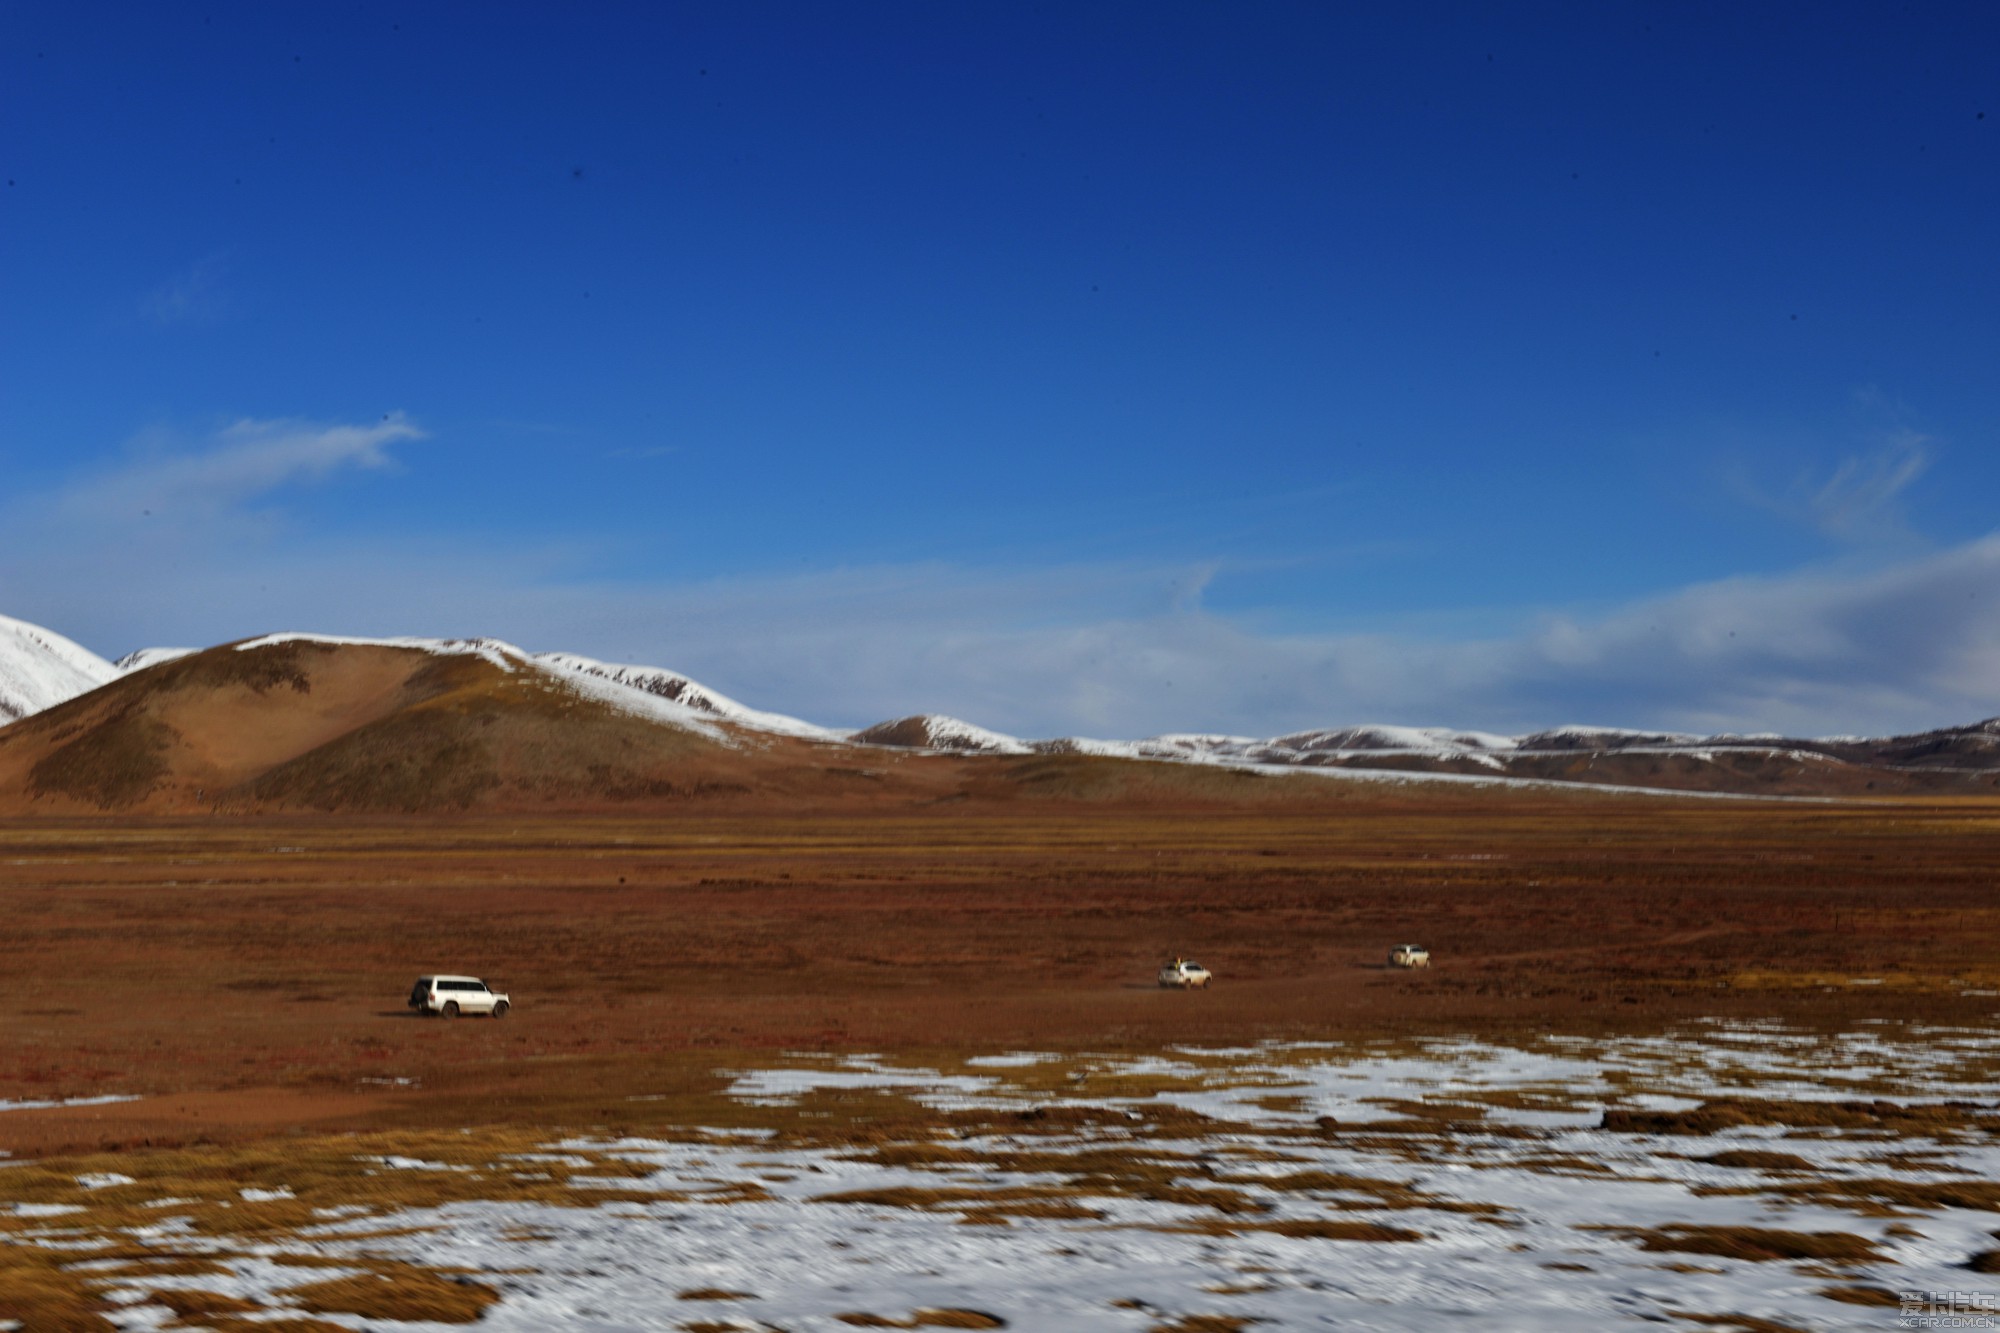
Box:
[0,4,2000,735]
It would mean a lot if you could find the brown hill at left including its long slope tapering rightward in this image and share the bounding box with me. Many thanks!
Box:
[0,638,1384,815]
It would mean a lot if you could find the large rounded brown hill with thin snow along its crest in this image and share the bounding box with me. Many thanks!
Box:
[0,640,892,813]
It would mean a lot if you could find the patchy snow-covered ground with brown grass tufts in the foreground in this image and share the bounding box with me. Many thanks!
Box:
[35,1025,2000,1333]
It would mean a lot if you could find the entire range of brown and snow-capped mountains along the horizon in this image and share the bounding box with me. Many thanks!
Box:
[0,618,2000,811]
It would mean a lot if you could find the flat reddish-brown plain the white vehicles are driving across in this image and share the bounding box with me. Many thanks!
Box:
[0,785,2000,1153]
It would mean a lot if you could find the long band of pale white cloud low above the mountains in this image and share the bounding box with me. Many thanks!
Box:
[0,416,2000,737]
